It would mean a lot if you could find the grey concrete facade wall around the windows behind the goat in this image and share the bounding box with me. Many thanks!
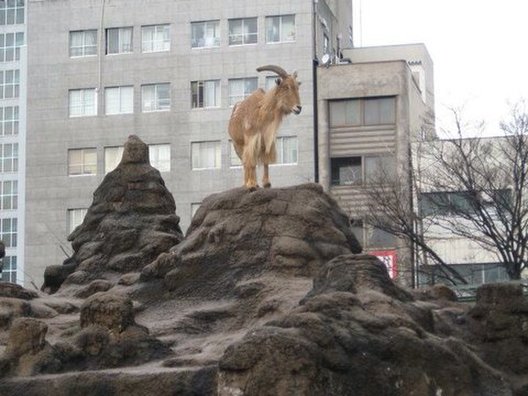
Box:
[26,0,340,286]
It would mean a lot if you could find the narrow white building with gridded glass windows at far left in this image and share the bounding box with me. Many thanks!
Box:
[0,0,28,283]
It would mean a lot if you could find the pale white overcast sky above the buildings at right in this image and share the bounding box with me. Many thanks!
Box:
[353,0,528,135]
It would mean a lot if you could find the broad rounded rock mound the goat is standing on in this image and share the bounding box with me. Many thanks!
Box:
[141,184,361,298]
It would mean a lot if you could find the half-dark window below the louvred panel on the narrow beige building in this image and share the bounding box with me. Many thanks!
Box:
[330,155,396,186]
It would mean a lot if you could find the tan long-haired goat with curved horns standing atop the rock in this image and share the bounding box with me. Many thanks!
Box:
[228,65,302,190]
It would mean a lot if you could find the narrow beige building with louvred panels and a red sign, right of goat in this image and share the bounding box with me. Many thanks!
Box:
[317,44,434,285]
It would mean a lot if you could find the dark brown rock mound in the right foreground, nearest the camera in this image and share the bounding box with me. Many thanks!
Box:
[218,255,511,396]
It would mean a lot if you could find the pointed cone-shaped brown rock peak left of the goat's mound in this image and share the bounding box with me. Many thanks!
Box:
[43,136,183,297]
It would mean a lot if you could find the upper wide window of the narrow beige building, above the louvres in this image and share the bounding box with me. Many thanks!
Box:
[329,97,396,127]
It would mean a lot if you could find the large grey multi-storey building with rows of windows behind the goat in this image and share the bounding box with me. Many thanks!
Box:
[25,0,352,285]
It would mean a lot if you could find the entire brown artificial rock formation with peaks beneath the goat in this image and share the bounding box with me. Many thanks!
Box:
[0,137,528,396]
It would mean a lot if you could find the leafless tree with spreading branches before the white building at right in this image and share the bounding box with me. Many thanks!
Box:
[366,102,528,283]
